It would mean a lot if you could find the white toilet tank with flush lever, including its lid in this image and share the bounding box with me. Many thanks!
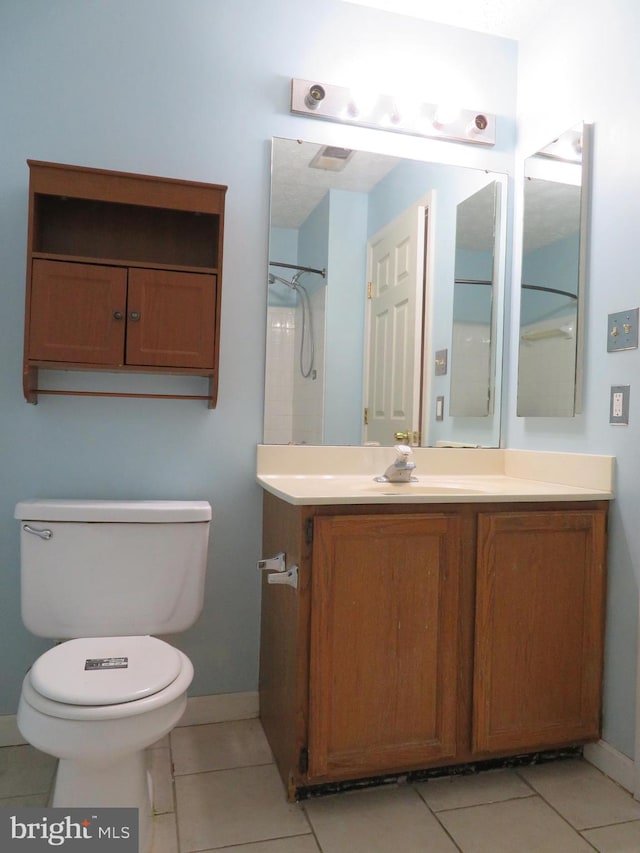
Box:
[14,500,211,639]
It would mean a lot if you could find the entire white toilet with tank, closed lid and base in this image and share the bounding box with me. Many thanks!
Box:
[15,500,211,853]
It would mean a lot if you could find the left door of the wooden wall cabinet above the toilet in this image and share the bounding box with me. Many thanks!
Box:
[29,260,127,365]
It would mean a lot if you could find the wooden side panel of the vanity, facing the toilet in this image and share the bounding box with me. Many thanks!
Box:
[259,493,310,797]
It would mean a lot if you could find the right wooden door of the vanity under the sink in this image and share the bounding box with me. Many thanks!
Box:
[473,510,606,752]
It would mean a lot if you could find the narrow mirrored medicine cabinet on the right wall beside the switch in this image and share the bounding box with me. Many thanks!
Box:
[517,124,591,417]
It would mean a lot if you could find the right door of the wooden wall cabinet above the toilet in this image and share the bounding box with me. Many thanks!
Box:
[126,268,216,368]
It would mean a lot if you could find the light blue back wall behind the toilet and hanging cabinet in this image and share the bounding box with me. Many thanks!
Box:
[0,0,517,713]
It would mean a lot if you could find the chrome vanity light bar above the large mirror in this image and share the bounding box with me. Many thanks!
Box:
[291,78,496,145]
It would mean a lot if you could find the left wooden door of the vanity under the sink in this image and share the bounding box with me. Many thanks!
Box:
[309,514,462,781]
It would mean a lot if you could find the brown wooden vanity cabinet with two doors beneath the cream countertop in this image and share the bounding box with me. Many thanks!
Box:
[260,493,607,798]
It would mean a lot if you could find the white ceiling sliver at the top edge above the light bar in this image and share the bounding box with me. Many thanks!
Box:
[344,0,559,40]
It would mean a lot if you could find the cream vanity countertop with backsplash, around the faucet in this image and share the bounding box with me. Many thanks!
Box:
[257,445,615,505]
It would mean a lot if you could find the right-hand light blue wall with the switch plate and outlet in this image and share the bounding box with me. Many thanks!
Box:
[505,0,640,756]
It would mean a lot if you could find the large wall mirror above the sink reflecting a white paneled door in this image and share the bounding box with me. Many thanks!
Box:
[264,138,507,447]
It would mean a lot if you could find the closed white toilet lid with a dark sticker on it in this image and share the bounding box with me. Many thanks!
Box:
[31,636,182,705]
